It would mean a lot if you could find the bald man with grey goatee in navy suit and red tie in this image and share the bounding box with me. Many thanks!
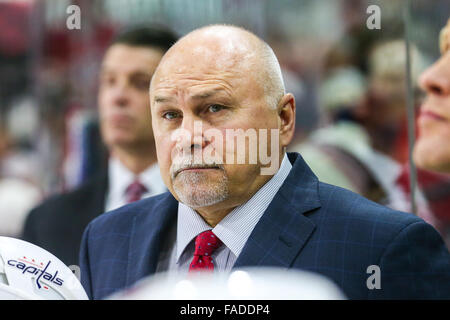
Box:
[80,25,450,299]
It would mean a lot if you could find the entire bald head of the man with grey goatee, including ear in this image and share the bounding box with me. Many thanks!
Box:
[150,25,295,220]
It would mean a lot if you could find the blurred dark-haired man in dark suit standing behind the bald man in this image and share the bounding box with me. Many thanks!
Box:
[23,27,177,265]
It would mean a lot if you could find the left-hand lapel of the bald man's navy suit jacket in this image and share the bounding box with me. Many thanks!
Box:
[126,192,178,285]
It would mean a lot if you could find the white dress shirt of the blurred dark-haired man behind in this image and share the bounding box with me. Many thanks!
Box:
[105,157,167,211]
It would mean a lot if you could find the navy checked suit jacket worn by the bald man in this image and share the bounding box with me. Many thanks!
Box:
[80,153,450,299]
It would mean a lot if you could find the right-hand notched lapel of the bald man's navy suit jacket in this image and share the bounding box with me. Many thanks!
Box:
[233,153,320,268]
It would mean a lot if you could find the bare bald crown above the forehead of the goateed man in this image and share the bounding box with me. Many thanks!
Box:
[152,25,285,109]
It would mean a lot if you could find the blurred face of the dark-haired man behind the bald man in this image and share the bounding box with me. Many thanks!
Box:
[98,44,163,151]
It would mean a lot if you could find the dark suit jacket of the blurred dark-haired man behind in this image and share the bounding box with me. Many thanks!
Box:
[22,171,108,265]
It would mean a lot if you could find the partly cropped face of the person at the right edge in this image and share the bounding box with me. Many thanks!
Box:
[414,51,450,173]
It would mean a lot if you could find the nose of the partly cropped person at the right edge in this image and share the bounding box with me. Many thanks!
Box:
[419,60,450,96]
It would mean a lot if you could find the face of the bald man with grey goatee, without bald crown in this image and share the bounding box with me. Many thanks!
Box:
[150,43,281,209]
